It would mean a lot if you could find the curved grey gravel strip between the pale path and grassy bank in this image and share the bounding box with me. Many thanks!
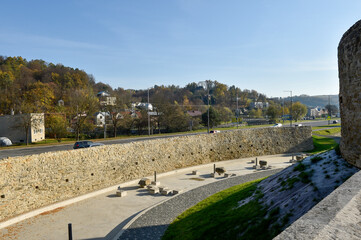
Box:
[118,169,283,240]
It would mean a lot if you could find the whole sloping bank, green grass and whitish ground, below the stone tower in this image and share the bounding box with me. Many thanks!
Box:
[162,136,358,240]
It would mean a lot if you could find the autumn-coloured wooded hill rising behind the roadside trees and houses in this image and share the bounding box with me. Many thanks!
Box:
[0,56,266,115]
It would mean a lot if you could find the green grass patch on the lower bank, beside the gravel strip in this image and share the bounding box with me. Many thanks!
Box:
[162,179,280,240]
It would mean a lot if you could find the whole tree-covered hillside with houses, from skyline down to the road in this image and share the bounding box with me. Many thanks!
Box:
[0,56,312,139]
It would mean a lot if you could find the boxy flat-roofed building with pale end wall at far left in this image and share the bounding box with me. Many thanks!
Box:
[0,113,45,143]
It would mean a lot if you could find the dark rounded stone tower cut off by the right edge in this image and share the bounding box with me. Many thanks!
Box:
[338,20,361,168]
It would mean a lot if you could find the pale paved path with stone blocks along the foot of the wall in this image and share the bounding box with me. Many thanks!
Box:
[0,154,291,240]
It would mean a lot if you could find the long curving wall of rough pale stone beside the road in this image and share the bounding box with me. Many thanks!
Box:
[0,127,313,221]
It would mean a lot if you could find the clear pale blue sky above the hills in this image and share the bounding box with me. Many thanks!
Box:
[0,0,361,97]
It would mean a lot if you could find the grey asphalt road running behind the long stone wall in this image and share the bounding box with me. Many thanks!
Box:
[0,121,338,159]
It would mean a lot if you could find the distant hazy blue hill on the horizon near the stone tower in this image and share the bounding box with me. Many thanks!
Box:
[285,95,339,107]
